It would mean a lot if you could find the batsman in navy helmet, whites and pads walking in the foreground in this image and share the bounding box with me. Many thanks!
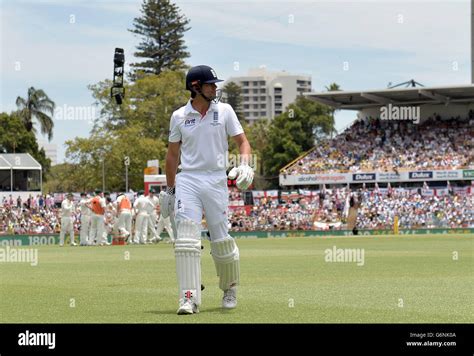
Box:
[161,65,254,314]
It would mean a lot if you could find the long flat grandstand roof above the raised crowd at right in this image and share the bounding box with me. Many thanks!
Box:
[303,85,474,110]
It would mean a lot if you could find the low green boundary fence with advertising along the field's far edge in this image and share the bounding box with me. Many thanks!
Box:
[0,228,474,247]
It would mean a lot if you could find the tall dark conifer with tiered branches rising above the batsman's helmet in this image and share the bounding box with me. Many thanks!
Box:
[129,0,190,74]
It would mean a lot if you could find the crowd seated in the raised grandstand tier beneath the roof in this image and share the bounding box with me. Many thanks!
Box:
[283,111,474,175]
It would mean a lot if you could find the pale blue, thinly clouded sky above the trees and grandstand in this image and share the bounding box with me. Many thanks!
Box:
[0,0,471,162]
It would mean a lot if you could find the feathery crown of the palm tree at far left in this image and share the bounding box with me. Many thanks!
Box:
[16,87,56,141]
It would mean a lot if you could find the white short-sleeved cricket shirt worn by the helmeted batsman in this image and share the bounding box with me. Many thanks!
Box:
[169,100,244,171]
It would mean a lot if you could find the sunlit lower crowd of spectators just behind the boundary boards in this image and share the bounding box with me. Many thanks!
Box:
[0,188,474,234]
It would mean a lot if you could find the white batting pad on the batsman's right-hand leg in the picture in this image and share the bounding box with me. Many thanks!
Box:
[211,236,240,291]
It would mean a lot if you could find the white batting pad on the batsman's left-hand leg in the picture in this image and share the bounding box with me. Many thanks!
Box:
[174,220,201,305]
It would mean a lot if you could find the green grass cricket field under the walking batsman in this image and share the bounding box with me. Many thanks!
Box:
[0,235,474,323]
